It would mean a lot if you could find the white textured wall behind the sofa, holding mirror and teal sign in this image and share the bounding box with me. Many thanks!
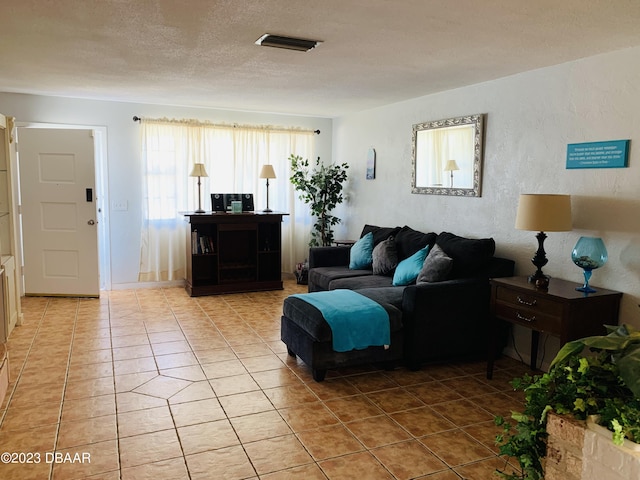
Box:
[333,48,640,366]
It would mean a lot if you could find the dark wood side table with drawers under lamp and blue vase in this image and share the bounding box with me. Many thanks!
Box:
[487,277,622,378]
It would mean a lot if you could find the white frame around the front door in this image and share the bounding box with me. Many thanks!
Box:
[13,121,111,296]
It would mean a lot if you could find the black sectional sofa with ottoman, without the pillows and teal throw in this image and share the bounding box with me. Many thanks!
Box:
[281,225,514,379]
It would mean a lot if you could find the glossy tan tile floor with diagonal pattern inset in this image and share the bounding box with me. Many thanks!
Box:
[0,281,526,480]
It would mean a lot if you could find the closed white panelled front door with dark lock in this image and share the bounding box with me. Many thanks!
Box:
[18,128,100,297]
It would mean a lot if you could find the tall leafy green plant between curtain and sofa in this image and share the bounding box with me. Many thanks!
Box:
[289,154,349,247]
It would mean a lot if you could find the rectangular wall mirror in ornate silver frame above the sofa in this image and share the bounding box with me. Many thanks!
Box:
[411,114,484,197]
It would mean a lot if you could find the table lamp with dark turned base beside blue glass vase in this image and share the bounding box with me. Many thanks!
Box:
[516,193,572,288]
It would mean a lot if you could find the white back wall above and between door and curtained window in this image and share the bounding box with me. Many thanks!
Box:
[0,93,332,288]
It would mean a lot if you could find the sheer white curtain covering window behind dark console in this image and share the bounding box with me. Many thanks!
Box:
[138,119,314,282]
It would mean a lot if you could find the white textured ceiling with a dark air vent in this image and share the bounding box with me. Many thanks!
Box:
[0,0,640,117]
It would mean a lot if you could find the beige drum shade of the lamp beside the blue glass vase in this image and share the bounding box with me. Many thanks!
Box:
[516,193,572,232]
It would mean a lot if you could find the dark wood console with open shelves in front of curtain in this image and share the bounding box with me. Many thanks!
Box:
[185,212,288,297]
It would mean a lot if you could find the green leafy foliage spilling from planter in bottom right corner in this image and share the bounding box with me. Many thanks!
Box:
[495,325,640,480]
